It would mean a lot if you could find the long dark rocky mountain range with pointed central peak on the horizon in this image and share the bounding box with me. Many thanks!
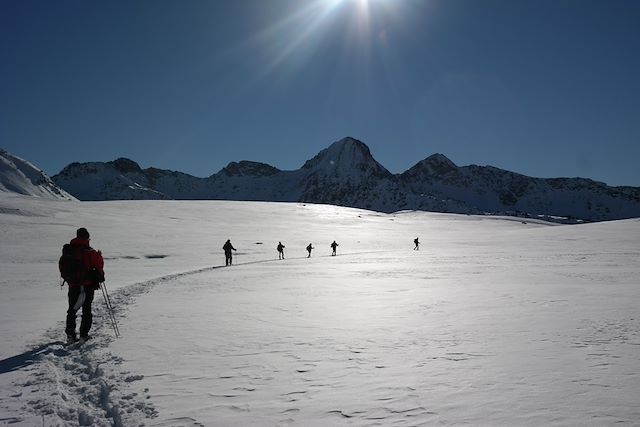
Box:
[48,137,640,221]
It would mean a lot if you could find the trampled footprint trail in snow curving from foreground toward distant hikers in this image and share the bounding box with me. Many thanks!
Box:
[7,251,389,427]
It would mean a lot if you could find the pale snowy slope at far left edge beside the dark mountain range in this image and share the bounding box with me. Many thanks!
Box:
[0,149,75,200]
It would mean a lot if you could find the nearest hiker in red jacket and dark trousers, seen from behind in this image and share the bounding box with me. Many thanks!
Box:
[59,227,104,342]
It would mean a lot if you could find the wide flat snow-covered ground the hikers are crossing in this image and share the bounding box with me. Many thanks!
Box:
[0,193,640,426]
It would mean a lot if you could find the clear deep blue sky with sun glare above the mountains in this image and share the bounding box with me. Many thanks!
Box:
[0,0,640,186]
